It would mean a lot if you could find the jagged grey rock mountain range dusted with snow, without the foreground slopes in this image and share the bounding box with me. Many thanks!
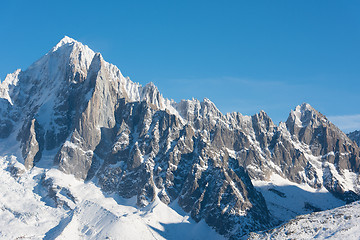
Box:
[0,37,360,238]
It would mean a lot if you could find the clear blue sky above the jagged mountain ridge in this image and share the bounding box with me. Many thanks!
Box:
[0,0,360,131]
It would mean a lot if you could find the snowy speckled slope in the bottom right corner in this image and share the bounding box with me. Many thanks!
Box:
[250,202,360,240]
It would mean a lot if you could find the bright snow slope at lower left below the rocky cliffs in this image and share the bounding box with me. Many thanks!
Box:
[0,156,223,240]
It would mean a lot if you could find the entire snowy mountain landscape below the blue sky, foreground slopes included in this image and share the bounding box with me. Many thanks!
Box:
[0,37,360,239]
